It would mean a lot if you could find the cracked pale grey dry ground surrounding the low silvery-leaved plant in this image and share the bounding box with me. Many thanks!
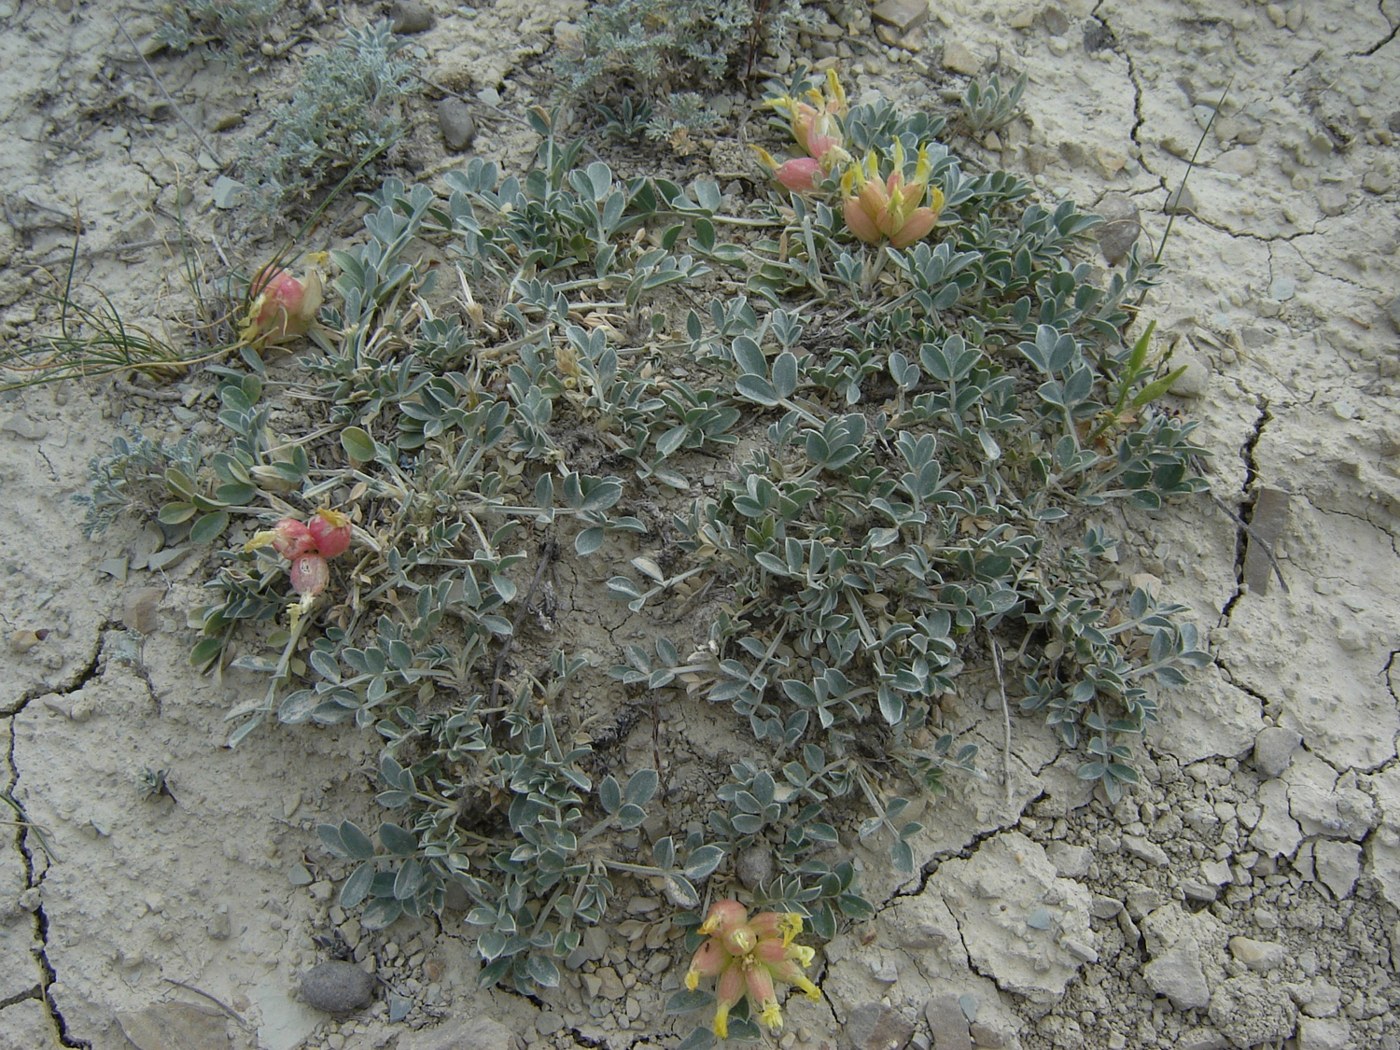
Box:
[0,0,1400,1050]
